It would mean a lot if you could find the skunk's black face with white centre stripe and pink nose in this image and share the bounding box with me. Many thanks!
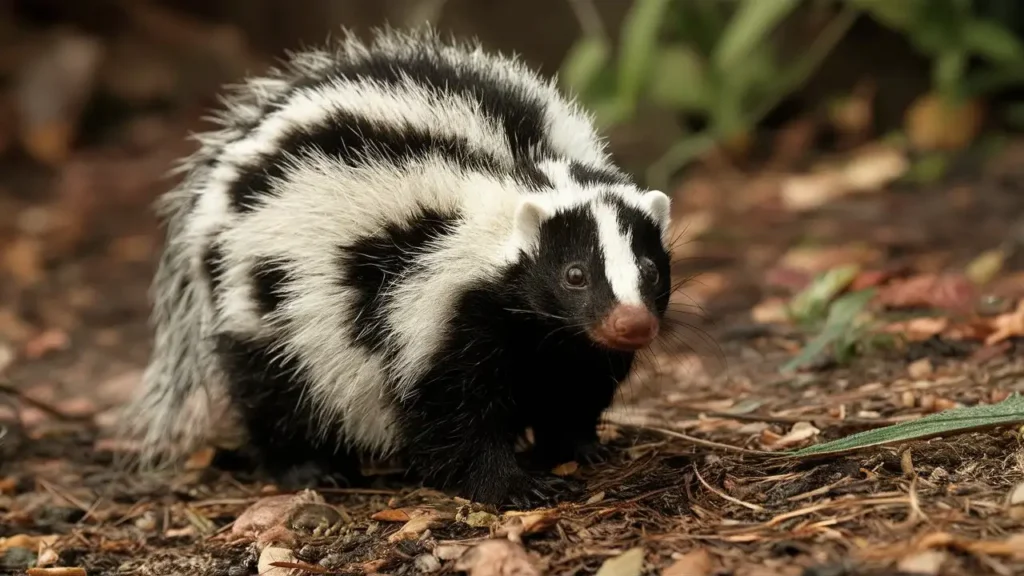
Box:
[512,193,671,352]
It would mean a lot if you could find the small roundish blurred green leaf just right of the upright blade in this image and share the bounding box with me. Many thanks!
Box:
[649,45,711,110]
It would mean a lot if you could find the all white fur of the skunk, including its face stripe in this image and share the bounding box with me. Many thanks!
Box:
[133,26,669,463]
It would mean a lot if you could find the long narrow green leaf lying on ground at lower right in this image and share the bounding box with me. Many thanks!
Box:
[788,393,1024,458]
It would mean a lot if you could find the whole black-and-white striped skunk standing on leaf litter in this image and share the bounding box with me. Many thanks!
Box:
[121,28,670,503]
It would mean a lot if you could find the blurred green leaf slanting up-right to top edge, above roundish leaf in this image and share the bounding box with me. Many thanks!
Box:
[712,0,799,72]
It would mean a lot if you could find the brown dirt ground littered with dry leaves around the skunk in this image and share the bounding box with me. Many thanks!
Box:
[0,4,1024,576]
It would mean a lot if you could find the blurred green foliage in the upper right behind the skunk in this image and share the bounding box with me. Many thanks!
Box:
[560,0,1024,187]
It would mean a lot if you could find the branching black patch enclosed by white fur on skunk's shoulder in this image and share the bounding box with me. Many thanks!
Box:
[338,203,460,353]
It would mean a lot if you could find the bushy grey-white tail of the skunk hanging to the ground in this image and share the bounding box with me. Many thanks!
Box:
[120,186,231,468]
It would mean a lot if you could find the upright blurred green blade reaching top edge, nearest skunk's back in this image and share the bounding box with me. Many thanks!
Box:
[617,0,670,108]
